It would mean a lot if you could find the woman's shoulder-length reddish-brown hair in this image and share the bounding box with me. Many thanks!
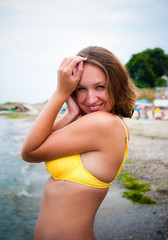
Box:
[77,46,136,118]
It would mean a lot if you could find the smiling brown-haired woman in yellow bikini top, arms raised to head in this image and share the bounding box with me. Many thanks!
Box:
[22,47,135,240]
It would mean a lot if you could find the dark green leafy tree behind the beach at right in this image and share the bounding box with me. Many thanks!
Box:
[126,48,168,88]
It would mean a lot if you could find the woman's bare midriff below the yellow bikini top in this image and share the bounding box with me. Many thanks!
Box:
[34,177,108,240]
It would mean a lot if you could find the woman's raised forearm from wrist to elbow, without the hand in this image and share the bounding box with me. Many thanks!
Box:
[21,90,67,161]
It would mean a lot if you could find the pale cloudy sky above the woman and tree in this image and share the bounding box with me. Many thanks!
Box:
[0,0,168,104]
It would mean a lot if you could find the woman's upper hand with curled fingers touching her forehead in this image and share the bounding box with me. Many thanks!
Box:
[57,56,87,98]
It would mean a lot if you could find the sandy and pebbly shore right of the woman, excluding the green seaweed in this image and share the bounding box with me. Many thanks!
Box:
[95,119,168,240]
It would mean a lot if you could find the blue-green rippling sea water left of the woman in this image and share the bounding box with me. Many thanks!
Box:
[0,116,49,240]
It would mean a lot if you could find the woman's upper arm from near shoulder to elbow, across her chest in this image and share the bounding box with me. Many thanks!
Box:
[21,112,115,162]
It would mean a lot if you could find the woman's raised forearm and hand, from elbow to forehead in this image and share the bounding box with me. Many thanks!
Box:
[21,56,86,161]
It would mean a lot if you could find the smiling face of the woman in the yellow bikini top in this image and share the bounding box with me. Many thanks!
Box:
[76,63,111,114]
